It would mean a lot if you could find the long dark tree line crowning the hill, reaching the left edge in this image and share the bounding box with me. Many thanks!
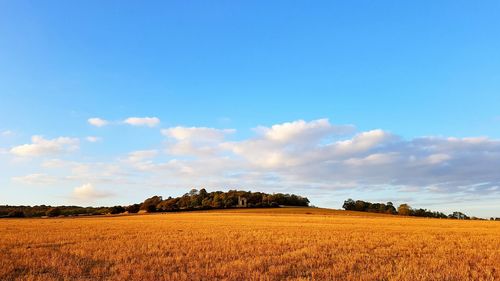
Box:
[0,189,309,218]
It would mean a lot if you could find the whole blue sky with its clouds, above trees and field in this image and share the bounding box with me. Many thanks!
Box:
[0,1,500,216]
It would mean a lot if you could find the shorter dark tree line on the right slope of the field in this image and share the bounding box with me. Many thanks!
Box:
[342,198,486,220]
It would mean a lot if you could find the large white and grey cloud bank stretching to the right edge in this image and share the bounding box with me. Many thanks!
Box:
[155,119,500,197]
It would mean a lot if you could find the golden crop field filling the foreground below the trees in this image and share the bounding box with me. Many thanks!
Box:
[0,208,500,281]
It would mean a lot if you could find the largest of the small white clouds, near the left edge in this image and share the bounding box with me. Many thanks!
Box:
[10,136,80,157]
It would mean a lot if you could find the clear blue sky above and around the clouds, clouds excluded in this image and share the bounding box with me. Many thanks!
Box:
[0,1,500,216]
